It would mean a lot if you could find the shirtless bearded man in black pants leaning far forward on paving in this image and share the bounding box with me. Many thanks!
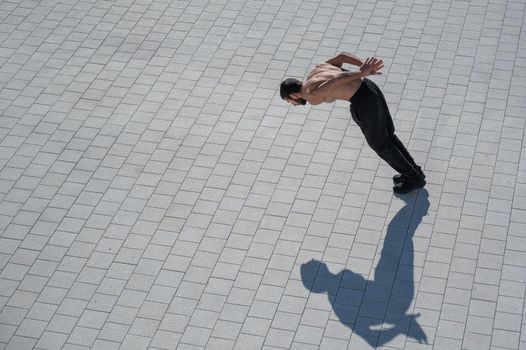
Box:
[280,52,426,194]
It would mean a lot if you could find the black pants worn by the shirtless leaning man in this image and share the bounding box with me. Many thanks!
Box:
[350,78,416,175]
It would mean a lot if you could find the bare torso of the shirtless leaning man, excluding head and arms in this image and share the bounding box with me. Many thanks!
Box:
[304,62,362,104]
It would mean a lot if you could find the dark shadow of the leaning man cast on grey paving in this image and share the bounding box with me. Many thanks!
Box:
[301,189,429,347]
